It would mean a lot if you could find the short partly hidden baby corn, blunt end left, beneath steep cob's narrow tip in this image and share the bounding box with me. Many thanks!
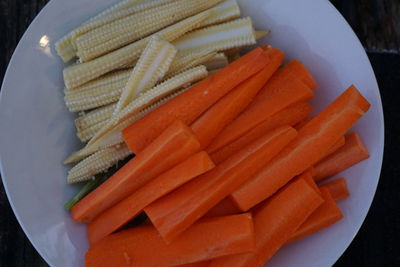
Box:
[75,104,116,131]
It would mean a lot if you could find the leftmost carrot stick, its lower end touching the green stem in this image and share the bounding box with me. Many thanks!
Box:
[71,121,200,222]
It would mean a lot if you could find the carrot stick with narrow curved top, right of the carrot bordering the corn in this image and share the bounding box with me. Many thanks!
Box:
[191,48,284,147]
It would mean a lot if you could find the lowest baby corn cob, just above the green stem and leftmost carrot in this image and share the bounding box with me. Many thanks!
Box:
[67,144,132,184]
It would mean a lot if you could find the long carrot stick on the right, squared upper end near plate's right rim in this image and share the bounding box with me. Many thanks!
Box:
[231,86,369,211]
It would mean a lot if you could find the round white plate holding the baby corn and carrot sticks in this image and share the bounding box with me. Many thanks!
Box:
[0,0,384,267]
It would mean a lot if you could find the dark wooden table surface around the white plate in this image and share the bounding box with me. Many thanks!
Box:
[0,0,400,267]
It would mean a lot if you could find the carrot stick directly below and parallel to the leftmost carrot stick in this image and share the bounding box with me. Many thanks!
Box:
[88,151,215,244]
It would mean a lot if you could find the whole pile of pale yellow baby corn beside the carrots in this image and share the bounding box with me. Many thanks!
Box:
[56,0,268,183]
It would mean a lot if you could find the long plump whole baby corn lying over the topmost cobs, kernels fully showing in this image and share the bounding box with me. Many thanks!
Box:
[76,0,221,62]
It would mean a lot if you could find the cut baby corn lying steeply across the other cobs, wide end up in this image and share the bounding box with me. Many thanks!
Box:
[114,35,177,115]
